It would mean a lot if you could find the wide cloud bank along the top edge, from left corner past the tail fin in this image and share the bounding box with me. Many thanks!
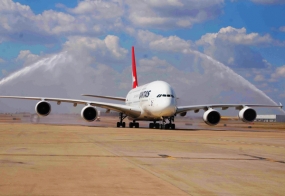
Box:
[0,0,224,44]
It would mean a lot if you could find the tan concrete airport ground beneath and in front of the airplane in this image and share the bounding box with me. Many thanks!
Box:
[0,117,285,196]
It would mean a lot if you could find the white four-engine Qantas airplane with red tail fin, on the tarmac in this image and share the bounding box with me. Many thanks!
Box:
[0,46,283,129]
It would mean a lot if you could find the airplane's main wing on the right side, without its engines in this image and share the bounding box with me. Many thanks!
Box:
[176,103,283,114]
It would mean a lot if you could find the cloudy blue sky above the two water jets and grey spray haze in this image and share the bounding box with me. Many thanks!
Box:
[0,0,285,112]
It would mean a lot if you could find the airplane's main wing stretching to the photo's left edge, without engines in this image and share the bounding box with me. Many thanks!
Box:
[0,96,141,117]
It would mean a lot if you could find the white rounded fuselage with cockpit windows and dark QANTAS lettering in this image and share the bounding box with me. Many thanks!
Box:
[126,81,176,120]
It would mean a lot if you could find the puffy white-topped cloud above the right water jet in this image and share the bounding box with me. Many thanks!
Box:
[196,26,282,68]
